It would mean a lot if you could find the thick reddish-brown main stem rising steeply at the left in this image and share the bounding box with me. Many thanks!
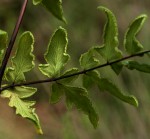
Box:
[0,0,28,86]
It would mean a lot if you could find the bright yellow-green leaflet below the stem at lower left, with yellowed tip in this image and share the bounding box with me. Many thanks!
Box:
[1,86,43,134]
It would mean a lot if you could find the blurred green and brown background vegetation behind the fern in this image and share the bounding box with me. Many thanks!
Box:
[0,0,150,139]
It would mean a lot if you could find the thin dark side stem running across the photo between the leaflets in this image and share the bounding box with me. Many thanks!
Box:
[0,50,150,91]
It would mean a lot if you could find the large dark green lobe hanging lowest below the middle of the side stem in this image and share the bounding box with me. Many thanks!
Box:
[62,85,99,128]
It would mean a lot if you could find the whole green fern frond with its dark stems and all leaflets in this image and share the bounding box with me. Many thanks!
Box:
[0,0,150,134]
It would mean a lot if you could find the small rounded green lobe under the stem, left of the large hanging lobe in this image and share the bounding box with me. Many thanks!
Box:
[50,83,64,103]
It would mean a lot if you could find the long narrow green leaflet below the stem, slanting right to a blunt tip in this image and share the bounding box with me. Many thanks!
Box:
[83,71,138,107]
